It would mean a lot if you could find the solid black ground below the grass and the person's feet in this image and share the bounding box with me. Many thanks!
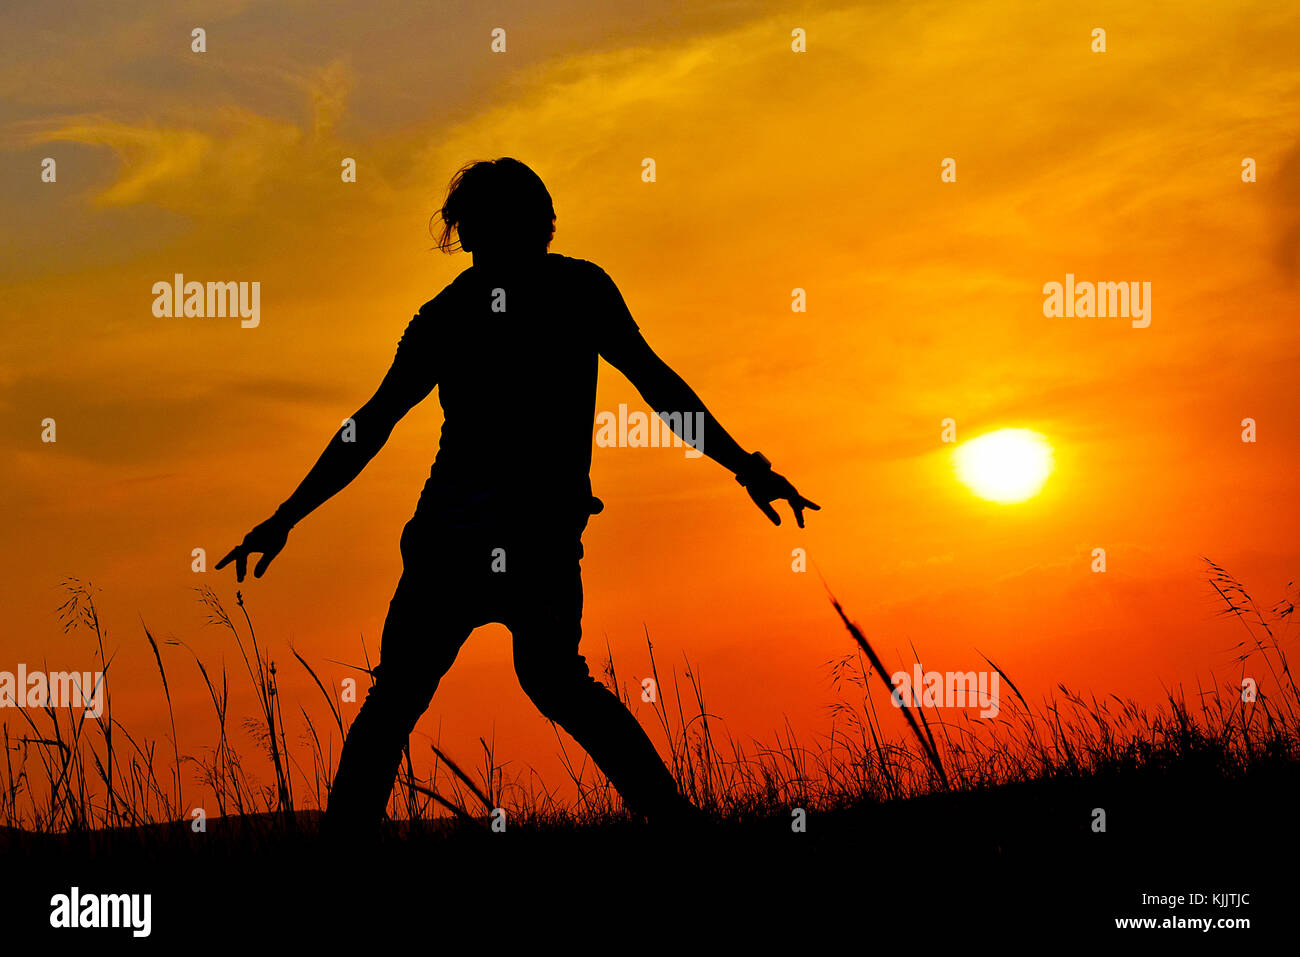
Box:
[0,763,1300,953]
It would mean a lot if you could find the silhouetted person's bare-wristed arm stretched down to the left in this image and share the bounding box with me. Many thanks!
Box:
[217,313,436,581]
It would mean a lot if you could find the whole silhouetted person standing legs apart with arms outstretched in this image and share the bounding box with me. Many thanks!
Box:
[217,159,818,831]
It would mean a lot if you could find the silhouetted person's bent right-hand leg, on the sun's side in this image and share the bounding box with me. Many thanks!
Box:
[506,535,696,820]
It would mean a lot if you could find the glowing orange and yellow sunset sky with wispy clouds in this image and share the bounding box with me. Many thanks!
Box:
[0,0,1300,806]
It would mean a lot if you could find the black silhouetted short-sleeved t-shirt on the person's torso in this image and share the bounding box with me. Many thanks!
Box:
[390,254,640,525]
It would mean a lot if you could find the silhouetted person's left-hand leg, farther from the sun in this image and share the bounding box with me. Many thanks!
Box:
[325,572,472,832]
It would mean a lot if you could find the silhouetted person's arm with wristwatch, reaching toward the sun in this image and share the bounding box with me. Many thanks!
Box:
[601,274,822,528]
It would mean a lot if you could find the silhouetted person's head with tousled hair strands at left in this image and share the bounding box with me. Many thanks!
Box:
[429,156,555,255]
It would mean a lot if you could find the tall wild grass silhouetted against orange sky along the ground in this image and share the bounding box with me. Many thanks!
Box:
[0,559,1300,833]
